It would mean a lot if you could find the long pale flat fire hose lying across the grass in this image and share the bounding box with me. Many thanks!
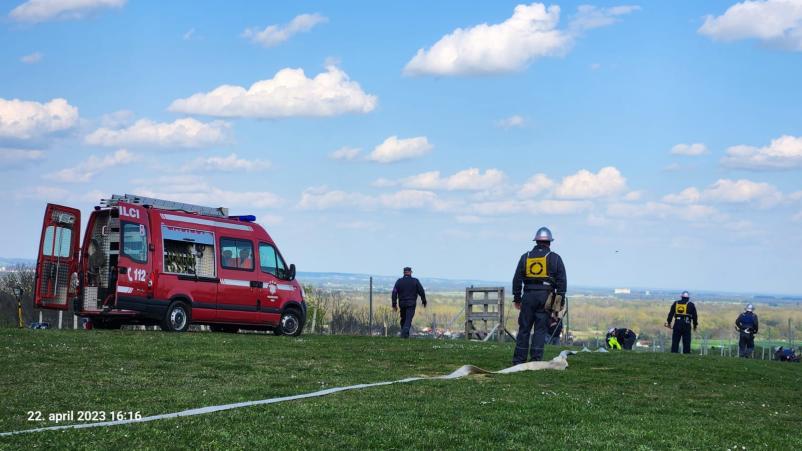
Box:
[0,348,607,437]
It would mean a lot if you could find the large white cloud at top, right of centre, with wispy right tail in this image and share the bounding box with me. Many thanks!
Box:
[404,3,637,75]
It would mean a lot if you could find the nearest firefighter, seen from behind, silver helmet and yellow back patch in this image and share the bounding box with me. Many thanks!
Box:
[512,227,568,365]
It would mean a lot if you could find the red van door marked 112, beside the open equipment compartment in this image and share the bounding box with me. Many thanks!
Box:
[117,203,154,302]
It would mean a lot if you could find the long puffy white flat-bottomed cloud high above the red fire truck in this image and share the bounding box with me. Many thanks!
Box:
[169,65,378,118]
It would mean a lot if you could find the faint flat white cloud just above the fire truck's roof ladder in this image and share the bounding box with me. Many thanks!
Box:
[136,175,285,214]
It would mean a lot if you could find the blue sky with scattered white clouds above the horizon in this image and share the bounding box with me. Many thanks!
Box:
[0,0,802,294]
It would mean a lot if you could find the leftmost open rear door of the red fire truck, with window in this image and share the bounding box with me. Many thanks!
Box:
[34,204,81,310]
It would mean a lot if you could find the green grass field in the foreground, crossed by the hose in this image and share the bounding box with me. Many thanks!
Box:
[0,329,802,450]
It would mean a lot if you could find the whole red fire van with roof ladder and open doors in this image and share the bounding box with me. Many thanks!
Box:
[34,194,306,336]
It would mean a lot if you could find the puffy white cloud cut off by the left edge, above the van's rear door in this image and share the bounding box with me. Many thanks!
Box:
[0,98,78,140]
